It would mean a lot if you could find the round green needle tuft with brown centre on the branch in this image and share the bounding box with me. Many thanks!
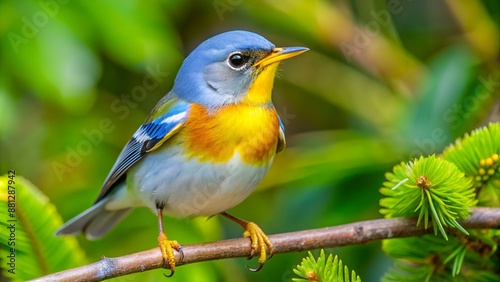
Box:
[380,155,477,239]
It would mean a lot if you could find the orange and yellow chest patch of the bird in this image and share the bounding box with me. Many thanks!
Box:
[183,105,279,165]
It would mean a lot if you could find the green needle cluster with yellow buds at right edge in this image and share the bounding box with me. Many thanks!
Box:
[443,123,500,207]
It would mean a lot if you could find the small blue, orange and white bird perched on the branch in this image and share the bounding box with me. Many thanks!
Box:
[56,30,309,276]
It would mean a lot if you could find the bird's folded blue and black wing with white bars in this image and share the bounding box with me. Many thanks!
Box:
[96,95,190,203]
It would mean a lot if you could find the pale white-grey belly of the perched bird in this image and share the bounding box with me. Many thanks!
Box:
[120,145,272,217]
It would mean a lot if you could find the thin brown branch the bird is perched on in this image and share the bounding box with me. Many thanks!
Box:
[31,208,500,282]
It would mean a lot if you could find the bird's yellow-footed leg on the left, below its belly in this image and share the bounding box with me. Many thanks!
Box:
[157,205,184,277]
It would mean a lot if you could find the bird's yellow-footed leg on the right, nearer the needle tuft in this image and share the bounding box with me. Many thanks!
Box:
[220,212,274,271]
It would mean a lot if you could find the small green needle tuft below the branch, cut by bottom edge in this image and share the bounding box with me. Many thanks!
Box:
[293,250,361,282]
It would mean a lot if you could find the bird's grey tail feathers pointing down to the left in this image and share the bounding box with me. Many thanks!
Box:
[56,199,131,240]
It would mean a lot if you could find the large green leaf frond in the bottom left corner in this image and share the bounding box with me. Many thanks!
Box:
[0,174,86,281]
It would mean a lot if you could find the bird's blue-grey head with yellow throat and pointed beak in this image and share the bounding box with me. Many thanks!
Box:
[173,31,308,107]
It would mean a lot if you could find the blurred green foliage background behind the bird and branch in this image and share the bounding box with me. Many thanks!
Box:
[0,0,500,281]
